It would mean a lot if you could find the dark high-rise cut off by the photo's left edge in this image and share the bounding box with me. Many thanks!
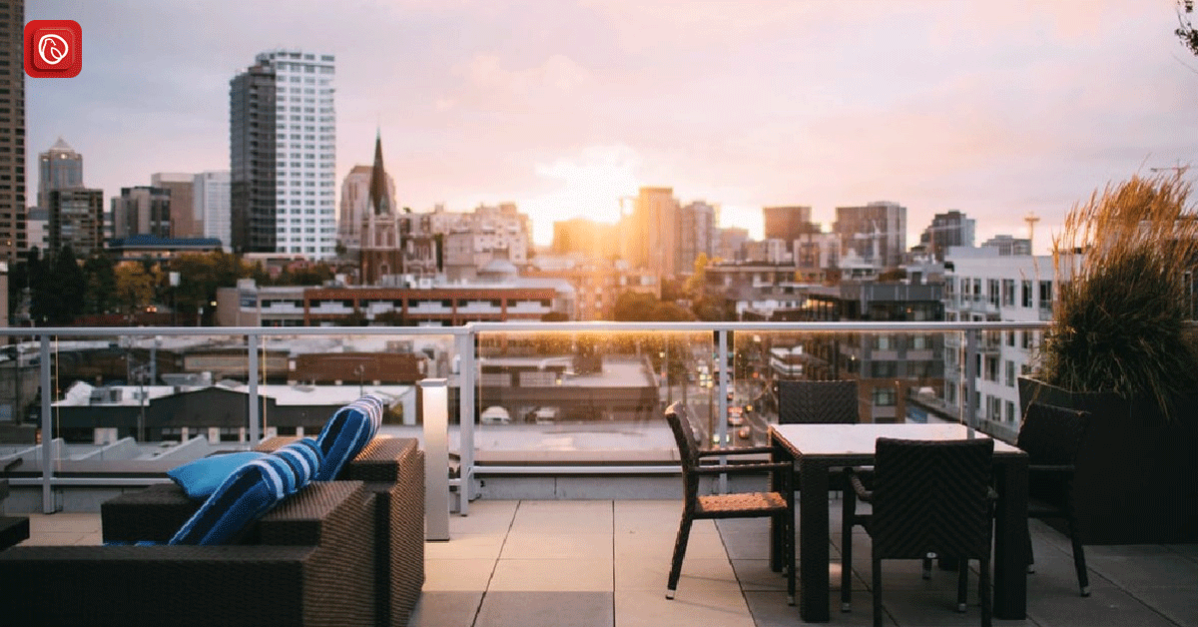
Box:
[0,0,25,262]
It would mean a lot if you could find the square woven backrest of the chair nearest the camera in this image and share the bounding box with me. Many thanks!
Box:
[870,438,994,559]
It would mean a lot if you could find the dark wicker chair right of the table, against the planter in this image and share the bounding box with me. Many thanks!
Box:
[1015,403,1090,597]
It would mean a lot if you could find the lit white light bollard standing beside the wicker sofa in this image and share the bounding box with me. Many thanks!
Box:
[419,379,449,541]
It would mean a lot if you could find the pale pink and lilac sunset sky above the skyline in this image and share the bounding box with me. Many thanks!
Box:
[25,0,1198,251]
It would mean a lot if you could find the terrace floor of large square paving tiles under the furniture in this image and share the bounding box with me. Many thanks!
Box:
[16,499,1198,627]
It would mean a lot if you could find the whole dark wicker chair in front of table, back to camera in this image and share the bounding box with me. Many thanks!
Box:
[841,438,997,627]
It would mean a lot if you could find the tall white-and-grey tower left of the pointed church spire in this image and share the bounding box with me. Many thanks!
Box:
[229,49,337,259]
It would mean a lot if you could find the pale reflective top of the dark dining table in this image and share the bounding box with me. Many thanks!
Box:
[769,422,1024,457]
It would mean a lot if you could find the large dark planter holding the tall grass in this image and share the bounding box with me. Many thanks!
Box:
[1019,376,1198,544]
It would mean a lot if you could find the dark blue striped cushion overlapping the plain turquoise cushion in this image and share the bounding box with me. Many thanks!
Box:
[170,456,298,544]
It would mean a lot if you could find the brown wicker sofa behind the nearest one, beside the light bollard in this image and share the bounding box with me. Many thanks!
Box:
[101,436,424,627]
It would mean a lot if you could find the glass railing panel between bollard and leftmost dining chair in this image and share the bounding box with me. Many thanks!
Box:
[474,330,718,464]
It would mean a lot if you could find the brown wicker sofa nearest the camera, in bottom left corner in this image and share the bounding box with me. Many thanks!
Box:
[0,481,377,627]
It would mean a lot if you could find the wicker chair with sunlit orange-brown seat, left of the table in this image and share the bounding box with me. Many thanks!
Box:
[666,403,794,605]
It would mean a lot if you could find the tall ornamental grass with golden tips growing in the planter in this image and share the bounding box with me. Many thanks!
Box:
[1039,170,1198,420]
